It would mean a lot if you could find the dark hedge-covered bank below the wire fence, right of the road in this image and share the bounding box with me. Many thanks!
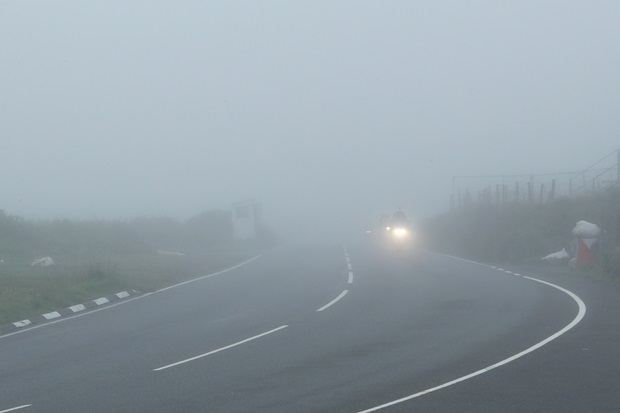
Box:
[422,189,620,279]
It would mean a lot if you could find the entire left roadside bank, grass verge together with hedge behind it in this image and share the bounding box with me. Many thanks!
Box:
[0,211,276,325]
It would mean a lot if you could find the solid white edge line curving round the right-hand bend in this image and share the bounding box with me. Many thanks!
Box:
[358,276,586,413]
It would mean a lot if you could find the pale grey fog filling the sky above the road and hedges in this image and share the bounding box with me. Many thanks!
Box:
[0,0,620,241]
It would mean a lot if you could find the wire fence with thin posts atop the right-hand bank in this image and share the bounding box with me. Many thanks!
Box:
[450,150,620,210]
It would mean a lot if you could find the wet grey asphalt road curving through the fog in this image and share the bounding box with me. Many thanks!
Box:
[0,245,620,413]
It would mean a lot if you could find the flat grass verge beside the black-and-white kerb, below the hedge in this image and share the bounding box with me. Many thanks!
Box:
[0,248,256,325]
